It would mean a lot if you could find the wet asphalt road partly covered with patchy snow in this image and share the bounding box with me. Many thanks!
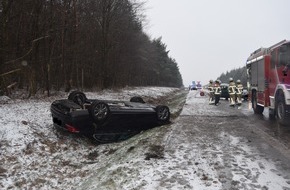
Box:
[163,91,290,190]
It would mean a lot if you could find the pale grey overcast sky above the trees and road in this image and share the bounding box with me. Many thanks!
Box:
[145,0,290,86]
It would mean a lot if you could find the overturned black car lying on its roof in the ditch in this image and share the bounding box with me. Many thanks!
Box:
[51,91,170,143]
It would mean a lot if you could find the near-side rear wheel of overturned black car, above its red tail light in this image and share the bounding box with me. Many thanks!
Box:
[89,101,110,123]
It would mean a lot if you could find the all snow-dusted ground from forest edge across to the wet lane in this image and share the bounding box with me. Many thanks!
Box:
[0,87,290,190]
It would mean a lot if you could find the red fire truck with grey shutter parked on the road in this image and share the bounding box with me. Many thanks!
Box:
[247,40,290,125]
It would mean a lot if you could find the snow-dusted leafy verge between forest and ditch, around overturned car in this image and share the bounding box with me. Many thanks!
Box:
[0,87,177,189]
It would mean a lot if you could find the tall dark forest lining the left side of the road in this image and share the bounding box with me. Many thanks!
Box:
[0,0,183,96]
